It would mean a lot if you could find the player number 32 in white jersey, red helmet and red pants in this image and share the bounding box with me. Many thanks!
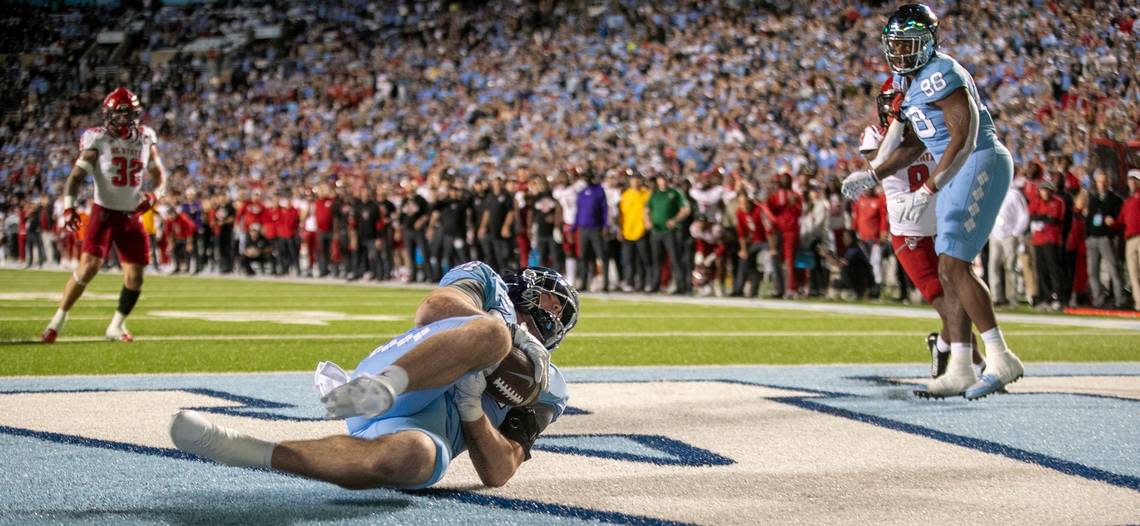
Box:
[41,88,166,343]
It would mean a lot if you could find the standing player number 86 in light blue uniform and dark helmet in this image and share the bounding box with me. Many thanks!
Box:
[844,3,1023,399]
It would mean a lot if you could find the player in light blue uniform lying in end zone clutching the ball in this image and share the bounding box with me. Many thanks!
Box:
[170,261,578,489]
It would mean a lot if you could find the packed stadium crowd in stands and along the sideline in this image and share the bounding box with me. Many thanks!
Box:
[0,1,1140,308]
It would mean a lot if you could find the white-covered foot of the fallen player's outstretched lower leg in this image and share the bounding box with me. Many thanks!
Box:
[170,410,274,468]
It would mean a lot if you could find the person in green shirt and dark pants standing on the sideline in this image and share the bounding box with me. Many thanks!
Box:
[645,176,690,294]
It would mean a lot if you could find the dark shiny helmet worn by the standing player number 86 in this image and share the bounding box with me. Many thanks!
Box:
[881,3,938,74]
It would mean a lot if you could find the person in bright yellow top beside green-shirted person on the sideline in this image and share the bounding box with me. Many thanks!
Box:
[618,172,653,292]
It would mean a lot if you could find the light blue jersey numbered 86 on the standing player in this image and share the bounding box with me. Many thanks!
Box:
[902,52,996,160]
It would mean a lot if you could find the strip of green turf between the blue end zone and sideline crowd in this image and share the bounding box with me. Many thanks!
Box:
[0,269,1140,375]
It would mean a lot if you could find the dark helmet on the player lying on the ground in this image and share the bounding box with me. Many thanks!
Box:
[503,267,578,350]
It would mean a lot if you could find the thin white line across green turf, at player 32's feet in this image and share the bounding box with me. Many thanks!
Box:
[0,331,1134,343]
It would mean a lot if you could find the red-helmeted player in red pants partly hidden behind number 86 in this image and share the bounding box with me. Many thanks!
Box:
[849,78,985,378]
